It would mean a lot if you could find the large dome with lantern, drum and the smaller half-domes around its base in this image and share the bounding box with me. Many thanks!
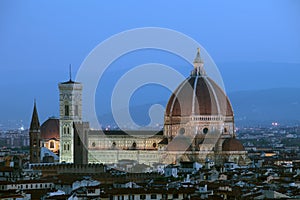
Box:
[164,49,249,165]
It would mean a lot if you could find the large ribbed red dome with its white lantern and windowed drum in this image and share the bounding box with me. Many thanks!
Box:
[164,49,234,138]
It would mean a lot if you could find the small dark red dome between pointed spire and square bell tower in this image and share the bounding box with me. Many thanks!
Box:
[41,118,59,140]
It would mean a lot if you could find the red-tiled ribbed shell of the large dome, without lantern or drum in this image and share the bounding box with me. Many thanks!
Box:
[165,76,233,117]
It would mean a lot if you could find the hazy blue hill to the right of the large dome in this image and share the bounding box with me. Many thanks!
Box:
[228,88,300,123]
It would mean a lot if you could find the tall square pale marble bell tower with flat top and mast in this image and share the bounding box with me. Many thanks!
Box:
[58,70,82,163]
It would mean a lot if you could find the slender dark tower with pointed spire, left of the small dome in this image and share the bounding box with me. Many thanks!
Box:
[29,101,41,163]
